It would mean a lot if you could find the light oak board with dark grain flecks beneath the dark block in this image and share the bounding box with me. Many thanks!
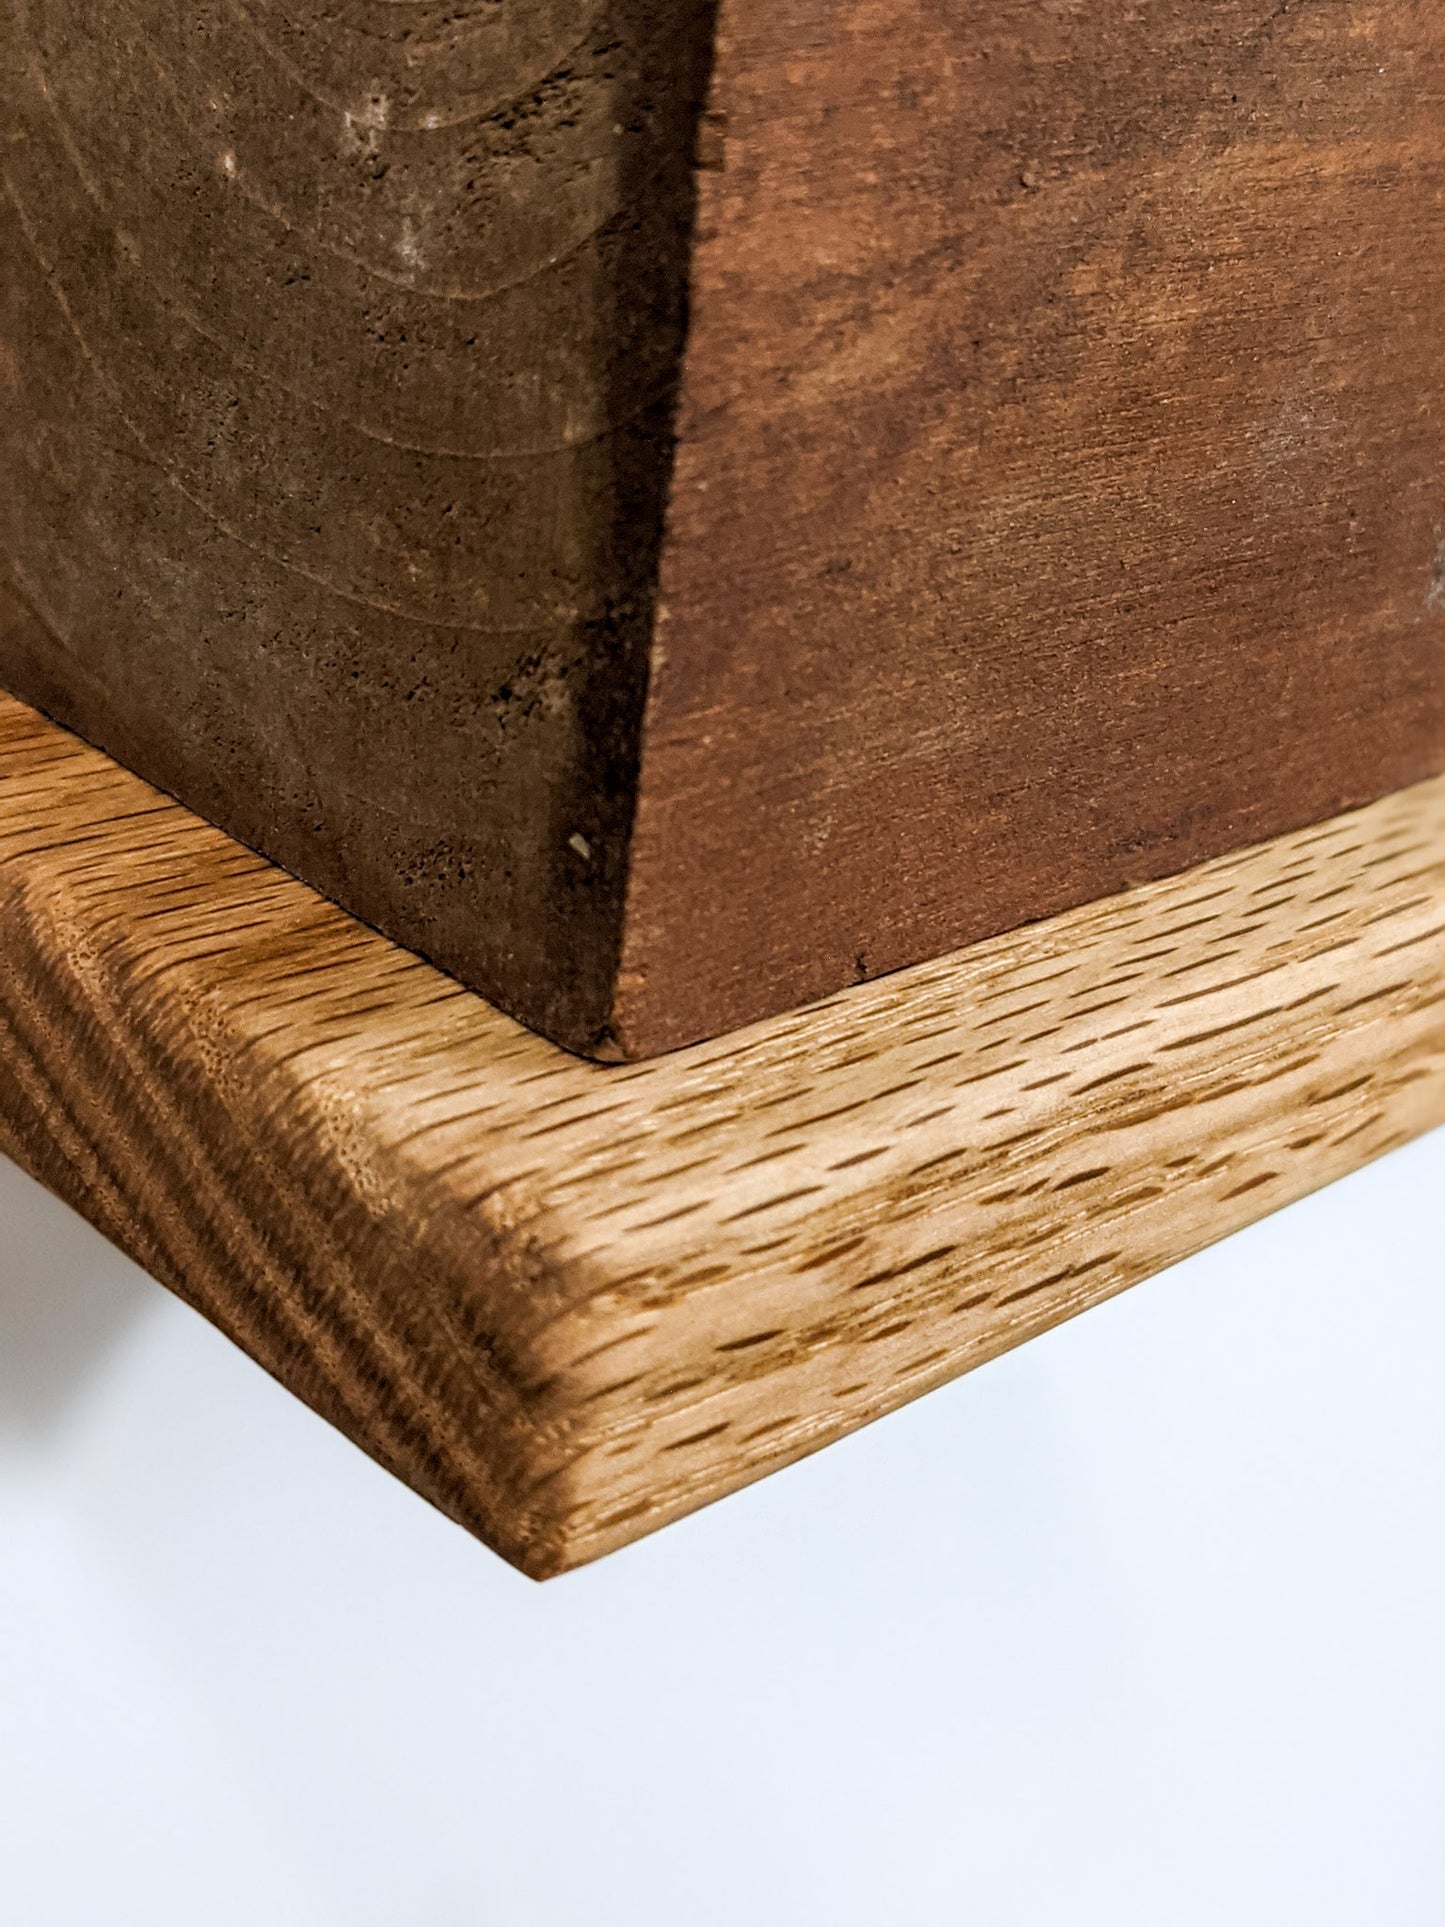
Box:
[0,700,1445,1574]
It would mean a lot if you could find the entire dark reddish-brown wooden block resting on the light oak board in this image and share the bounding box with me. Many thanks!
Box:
[0,0,1445,1058]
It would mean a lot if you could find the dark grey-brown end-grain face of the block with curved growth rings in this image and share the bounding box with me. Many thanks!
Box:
[0,0,707,1048]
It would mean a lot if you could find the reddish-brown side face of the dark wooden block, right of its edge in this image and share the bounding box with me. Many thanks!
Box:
[618,0,1445,1052]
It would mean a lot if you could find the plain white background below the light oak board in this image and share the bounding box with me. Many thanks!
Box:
[0,1135,1445,1927]
